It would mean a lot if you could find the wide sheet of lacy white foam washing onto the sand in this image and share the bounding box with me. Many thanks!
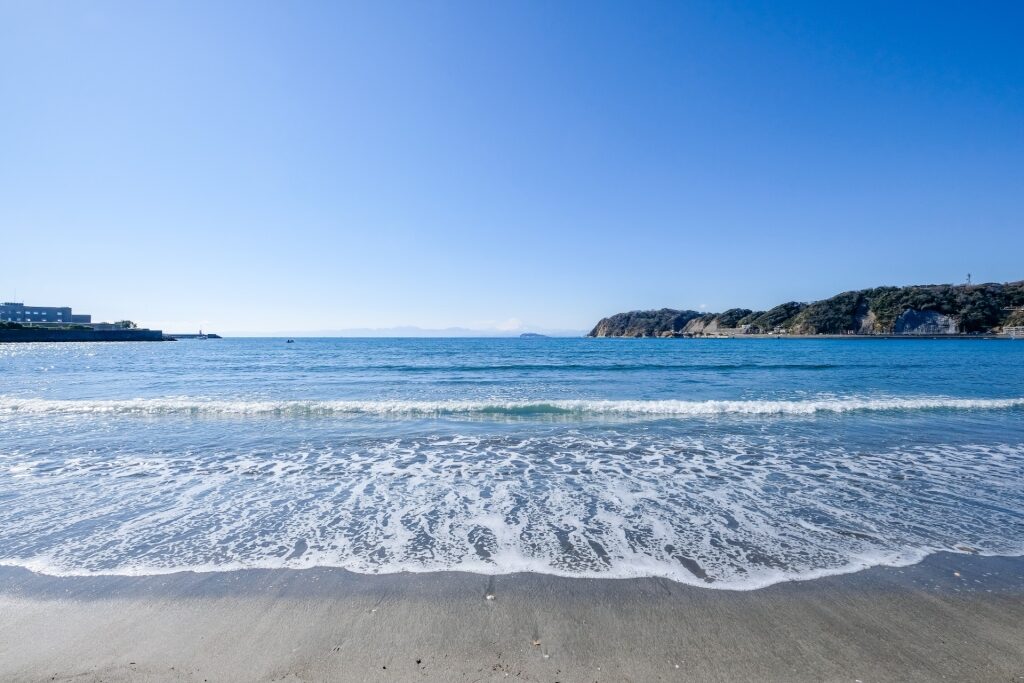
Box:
[0,425,1024,590]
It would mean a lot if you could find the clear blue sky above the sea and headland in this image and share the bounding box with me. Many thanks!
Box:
[0,0,1024,332]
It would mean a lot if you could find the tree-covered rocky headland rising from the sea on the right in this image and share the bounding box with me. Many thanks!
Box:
[588,281,1024,337]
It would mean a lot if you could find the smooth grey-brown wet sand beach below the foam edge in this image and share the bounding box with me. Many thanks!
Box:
[0,554,1024,683]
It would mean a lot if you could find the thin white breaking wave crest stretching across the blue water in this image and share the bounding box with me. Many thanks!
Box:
[0,396,1024,418]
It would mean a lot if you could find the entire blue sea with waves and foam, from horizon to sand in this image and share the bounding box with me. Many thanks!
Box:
[0,339,1024,589]
